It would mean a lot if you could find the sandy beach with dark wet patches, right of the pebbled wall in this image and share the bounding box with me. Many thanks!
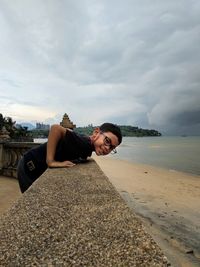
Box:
[94,156,200,267]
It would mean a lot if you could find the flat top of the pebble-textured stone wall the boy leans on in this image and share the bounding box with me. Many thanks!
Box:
[0,160,169,267]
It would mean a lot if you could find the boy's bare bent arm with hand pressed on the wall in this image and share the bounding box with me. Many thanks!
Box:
[46,124,75,167]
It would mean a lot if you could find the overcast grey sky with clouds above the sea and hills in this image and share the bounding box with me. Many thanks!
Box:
[0,0,200,134]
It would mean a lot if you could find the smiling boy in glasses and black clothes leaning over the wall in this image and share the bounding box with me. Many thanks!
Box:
[17,123,122,193]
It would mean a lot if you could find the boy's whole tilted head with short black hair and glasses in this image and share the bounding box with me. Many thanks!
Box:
[91,122,122,156]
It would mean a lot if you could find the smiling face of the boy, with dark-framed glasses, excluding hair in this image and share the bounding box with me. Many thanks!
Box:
[92,128,119,156]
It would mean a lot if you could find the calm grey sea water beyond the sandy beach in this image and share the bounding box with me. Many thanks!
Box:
[34,136,200,175]
